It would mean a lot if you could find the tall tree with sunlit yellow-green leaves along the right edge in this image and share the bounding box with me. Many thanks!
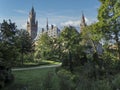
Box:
[98,0,120,59]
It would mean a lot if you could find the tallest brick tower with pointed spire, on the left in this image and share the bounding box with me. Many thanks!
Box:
[27,7,38,41]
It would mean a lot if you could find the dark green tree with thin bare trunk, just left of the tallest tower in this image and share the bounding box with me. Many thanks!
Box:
[16,29,34,65]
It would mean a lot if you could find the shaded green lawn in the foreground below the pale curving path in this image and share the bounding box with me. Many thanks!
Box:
[3,68,59,90]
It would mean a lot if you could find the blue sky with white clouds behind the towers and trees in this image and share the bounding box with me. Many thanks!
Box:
[0,0,100,30]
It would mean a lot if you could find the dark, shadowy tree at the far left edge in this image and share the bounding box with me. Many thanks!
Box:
[0,20,18,66]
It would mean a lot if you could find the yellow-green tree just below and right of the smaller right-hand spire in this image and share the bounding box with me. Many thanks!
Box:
[81,23,102,53]
